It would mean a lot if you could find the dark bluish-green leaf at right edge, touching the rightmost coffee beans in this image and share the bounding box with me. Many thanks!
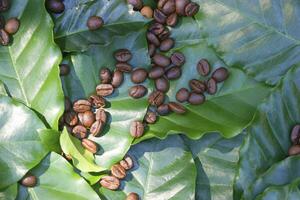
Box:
[235,67,300,199]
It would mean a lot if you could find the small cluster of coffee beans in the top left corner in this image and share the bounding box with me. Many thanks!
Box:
[0,0,20,46]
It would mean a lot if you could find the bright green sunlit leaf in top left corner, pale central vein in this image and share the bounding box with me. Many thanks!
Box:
[0,0,64,129]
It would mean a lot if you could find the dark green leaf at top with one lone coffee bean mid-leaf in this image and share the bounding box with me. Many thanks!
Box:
[54,0,149,52]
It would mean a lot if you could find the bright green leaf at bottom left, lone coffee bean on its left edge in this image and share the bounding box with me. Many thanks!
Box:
[17,153,100,200]
